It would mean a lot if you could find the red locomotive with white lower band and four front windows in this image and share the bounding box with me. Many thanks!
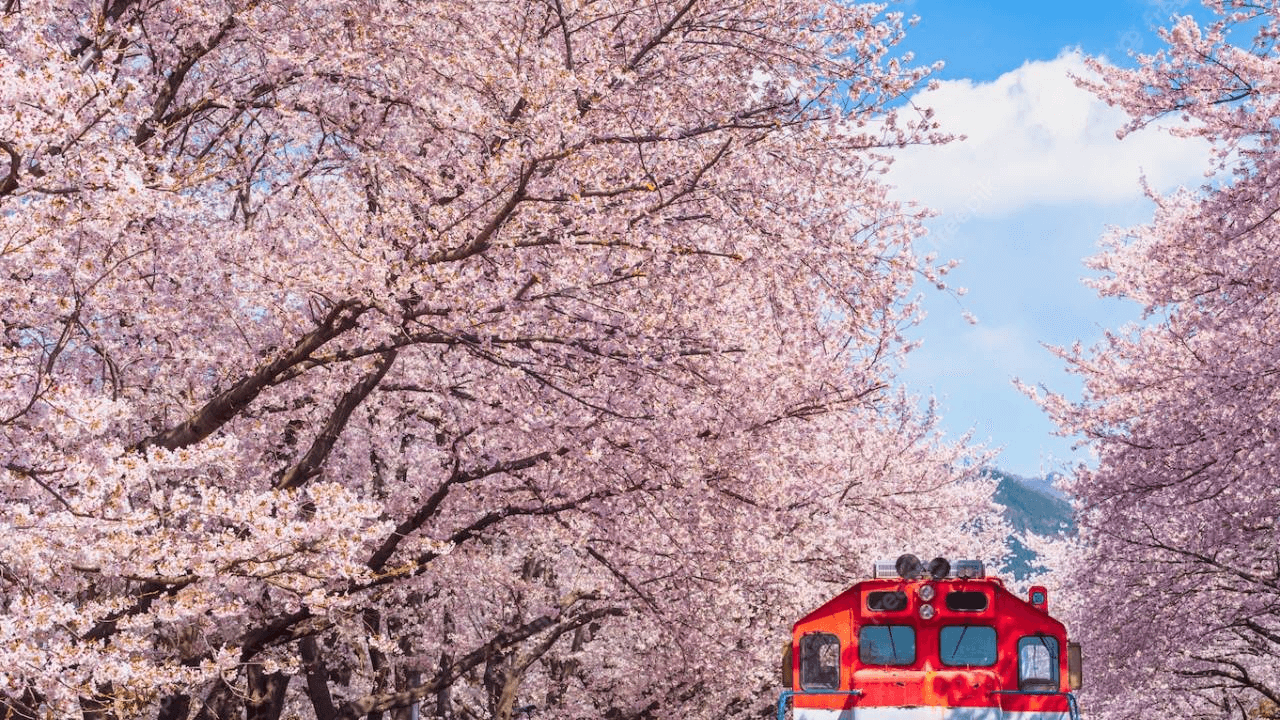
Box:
[778,555,1080,720]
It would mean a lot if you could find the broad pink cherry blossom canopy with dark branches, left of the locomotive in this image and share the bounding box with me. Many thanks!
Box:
[0,0,1004,720]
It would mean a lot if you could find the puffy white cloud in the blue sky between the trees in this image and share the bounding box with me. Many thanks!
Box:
[890,53,1208,217]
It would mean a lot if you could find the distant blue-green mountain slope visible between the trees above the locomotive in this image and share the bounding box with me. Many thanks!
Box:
[987,468,1075,580]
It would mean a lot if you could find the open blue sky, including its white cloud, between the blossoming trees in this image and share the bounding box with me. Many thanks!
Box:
[890,0,1207,477]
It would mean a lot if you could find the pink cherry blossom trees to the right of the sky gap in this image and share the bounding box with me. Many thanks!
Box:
[1046,1,1280,717]
